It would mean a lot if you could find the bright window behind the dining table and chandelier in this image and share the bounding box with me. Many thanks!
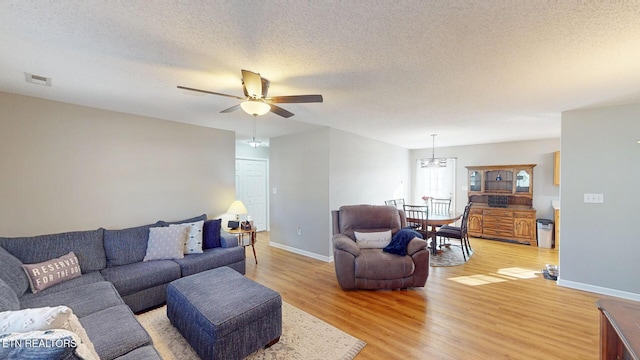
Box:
[413,158,456,211]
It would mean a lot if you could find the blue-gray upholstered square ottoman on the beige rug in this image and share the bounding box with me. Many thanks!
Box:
[167,267,282,360]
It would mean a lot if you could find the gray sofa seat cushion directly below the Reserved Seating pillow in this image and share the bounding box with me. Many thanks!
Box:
[20,275,124,318]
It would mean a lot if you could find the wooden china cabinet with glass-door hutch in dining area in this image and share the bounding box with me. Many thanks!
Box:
[467,164,537,246]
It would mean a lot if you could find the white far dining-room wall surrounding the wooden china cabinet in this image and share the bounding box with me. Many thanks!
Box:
[411,139,564,219]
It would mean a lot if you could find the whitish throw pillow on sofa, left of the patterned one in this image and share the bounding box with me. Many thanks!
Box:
[142,226,187,261]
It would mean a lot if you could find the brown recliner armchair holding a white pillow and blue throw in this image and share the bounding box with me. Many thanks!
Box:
[331,205,429,290]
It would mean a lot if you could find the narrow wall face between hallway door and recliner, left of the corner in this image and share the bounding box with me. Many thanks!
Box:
[269,128,330,260]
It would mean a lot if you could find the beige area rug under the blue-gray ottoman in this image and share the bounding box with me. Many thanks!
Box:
[137,301,365,360]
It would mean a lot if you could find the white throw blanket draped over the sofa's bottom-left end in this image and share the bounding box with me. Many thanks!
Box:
[0,306,100,360]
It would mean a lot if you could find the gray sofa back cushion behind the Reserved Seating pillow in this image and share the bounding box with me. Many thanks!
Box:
[0,228,107,272]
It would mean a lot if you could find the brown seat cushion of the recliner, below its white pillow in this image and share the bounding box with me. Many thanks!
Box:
[354,249,415,280]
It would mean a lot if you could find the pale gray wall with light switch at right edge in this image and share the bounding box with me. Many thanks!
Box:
[558,104,640,300]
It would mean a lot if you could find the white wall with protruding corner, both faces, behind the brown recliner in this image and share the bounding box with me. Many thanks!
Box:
[269,128,411,261]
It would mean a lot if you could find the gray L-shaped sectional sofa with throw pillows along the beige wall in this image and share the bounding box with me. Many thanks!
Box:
[0,215,245,360]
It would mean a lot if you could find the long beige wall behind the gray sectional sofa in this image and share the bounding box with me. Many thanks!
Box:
[0,93,235,236]
